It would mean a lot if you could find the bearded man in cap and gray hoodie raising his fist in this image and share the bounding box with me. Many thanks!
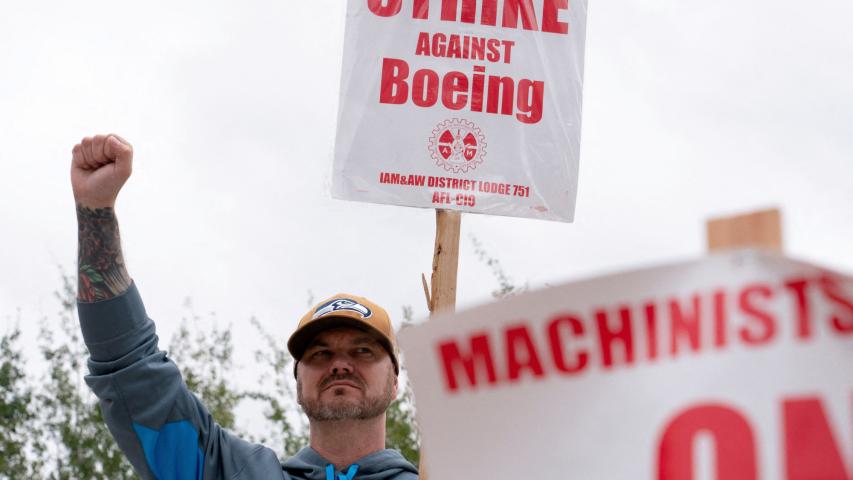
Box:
[71,135,417,480]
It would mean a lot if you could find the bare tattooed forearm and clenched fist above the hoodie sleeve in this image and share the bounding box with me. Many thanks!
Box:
[71,135,133,303]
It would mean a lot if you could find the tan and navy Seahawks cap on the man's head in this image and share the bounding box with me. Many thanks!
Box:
[287,293,400,376]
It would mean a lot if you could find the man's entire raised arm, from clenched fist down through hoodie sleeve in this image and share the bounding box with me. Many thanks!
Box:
[71,135,282,480]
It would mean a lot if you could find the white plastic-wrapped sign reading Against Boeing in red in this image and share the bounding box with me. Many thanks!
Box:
[332,0,587,221]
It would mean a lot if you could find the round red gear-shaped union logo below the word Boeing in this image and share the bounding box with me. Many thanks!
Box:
[429,118,486,173]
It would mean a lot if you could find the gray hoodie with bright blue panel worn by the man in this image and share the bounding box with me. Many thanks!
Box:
[78,284,418,480]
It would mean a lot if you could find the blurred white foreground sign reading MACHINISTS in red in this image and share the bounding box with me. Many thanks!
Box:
[400,251,853,480]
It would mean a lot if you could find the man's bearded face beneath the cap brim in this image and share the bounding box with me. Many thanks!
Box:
[296,327,397,421]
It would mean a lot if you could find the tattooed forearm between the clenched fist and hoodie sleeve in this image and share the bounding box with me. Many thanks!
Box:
[77,205,130,302]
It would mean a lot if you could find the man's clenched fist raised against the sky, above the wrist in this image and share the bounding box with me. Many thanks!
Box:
[71,134,133,208]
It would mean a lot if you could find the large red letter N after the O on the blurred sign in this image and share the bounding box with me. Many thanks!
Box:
[782,398,853,480]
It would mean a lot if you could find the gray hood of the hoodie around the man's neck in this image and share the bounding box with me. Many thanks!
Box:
[282,447,418,480]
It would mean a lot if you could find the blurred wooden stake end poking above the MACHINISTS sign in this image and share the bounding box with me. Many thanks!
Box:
[706,208,782,252]
